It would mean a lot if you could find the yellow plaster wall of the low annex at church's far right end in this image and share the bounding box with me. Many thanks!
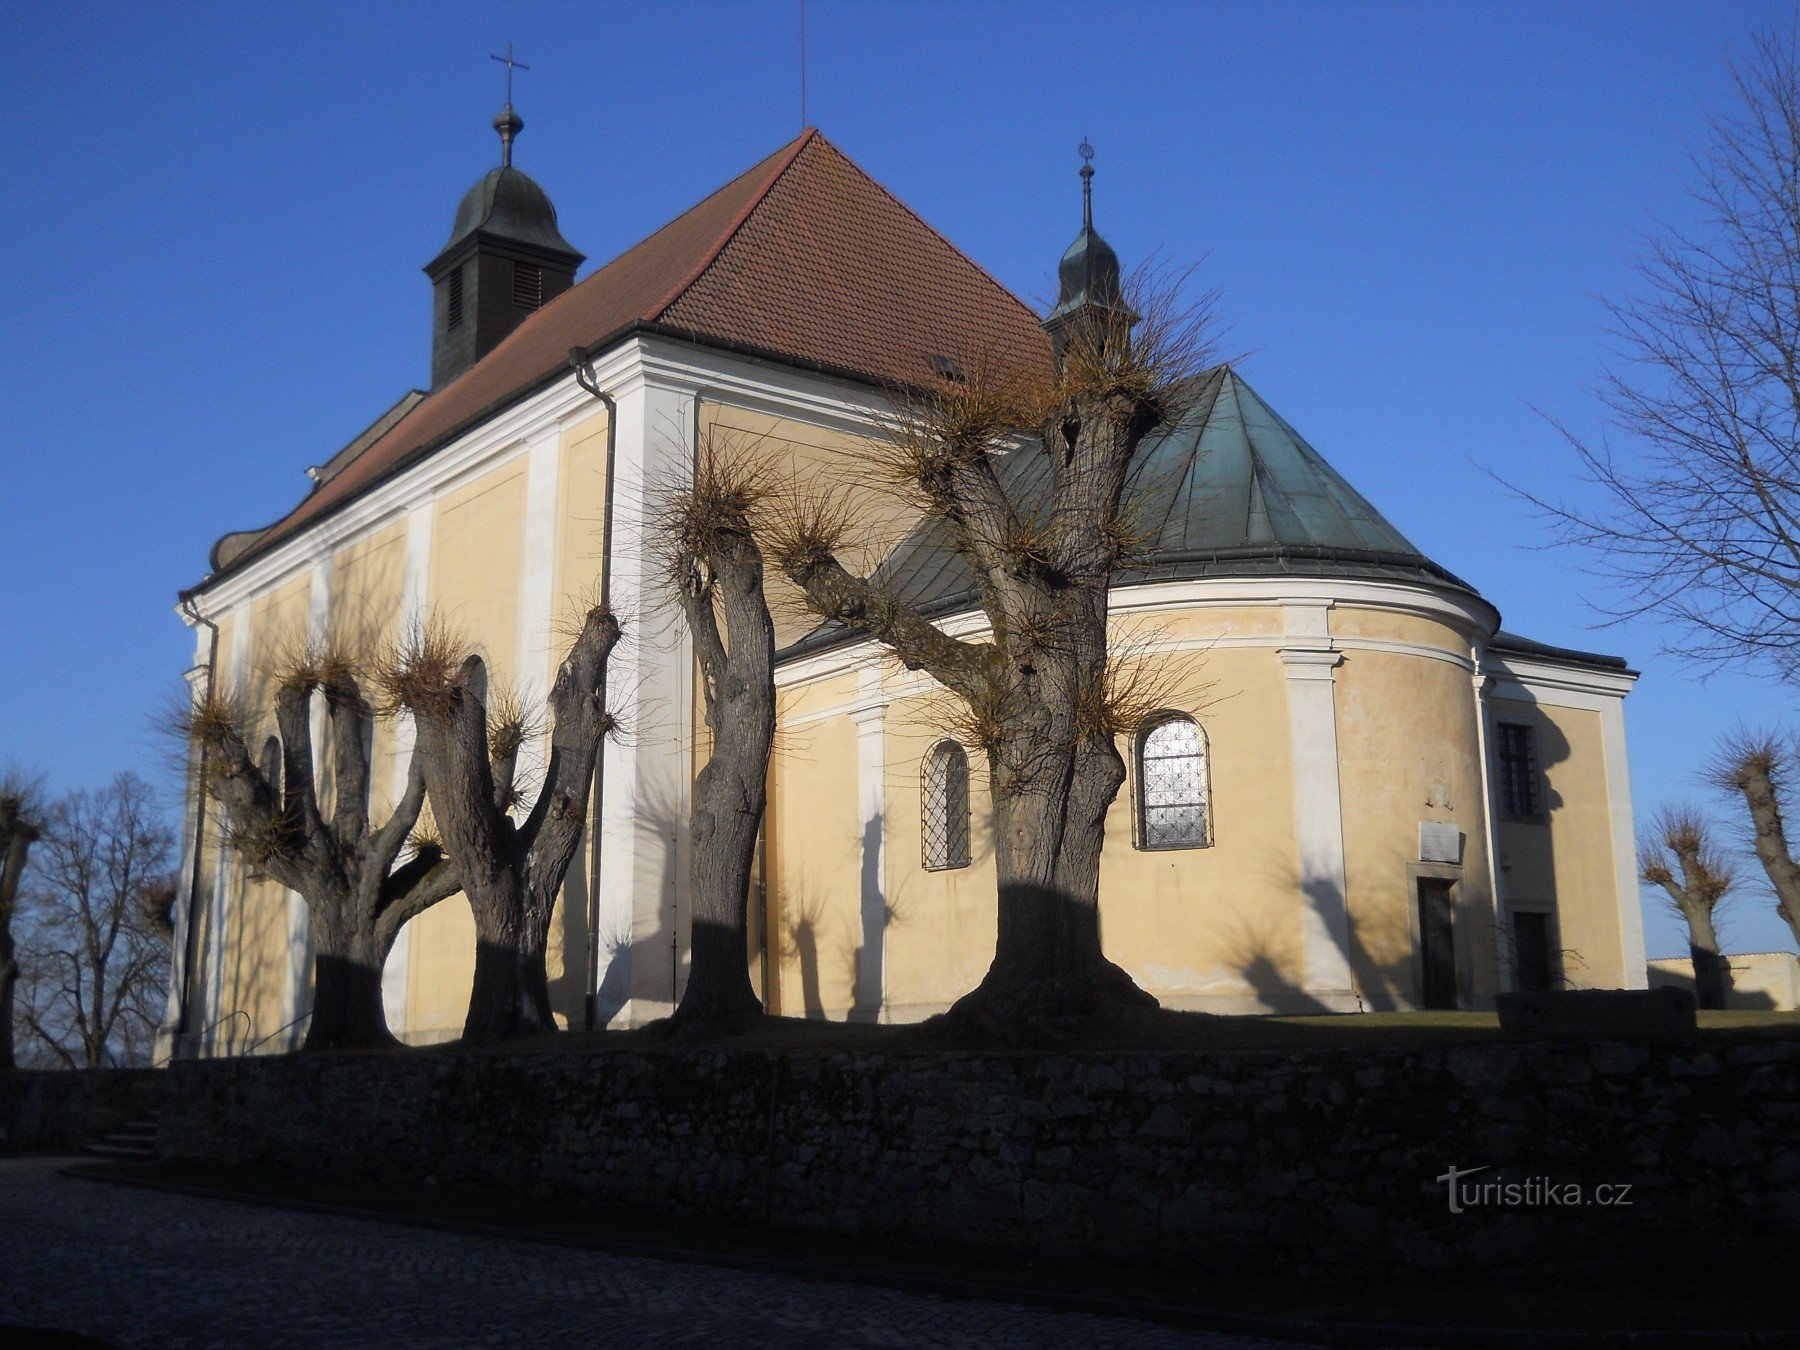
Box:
[1492,698,1642,988]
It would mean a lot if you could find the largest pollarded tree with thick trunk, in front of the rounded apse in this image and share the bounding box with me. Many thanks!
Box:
[767,274,1204,1039]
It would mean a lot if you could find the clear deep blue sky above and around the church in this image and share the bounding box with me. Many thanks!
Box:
[0,0,1795,954]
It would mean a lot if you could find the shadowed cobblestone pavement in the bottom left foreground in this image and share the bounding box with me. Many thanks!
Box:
[0,1157,1324,1350]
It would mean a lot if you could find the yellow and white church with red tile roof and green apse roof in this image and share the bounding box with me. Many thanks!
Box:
[169,104,1645,1055]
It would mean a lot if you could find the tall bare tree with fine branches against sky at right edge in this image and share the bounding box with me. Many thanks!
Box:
[1523,32,1800,680]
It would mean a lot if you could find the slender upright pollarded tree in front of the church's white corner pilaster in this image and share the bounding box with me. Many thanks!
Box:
[653,445,776,1028]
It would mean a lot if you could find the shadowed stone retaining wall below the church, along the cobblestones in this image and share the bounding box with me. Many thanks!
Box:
[136,1042,1800,1276]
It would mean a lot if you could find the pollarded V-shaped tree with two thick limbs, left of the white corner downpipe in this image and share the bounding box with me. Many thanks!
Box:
[383,605,619,1044]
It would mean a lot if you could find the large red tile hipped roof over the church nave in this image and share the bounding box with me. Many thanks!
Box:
[207,131,1049,586]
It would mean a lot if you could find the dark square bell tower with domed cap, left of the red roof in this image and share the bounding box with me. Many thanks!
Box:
[425,99,585,389]
